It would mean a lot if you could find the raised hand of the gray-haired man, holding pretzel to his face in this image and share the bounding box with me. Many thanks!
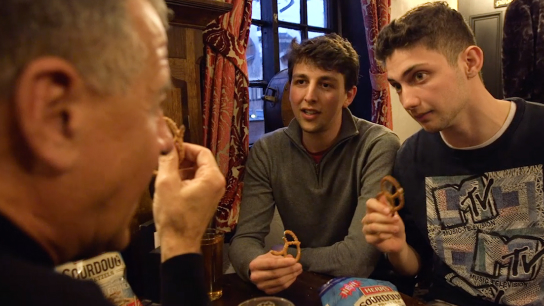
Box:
[153,143,225,262]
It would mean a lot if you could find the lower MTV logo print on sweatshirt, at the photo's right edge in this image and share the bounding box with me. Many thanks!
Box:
[472,232,544,282]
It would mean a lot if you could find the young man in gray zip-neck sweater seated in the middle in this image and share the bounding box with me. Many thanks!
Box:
[229,34,399,294]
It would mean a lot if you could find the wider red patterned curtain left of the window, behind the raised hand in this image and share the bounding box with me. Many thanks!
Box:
[202,0,252,232]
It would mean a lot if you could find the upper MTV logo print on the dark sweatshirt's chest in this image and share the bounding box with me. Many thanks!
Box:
[430,174,498,229]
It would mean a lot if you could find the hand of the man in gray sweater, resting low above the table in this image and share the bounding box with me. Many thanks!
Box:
[249,252,302,294]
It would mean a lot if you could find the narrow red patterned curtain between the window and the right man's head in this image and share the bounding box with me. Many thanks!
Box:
[361,0,393,129]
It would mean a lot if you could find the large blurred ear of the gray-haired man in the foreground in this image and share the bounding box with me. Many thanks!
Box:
[13,57,84,173]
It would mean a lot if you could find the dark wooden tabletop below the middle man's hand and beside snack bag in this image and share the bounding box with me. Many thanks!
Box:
[212,271,424,306]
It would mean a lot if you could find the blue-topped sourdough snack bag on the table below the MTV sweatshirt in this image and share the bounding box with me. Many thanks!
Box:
[319,277,406,306]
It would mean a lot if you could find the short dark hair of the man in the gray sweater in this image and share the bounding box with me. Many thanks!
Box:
[287,33,359,91]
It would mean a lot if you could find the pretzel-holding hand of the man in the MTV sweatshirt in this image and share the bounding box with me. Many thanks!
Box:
[361,196,407,253]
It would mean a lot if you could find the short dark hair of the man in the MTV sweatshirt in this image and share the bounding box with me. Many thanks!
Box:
[375,1,476,65]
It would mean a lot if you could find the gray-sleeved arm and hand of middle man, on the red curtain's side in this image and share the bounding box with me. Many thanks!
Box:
[229,141,302,294]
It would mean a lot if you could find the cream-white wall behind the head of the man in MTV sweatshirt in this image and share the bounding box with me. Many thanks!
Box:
[389,0,458,142]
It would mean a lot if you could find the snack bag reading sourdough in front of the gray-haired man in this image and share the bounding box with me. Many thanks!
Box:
[55,252,142,306]
